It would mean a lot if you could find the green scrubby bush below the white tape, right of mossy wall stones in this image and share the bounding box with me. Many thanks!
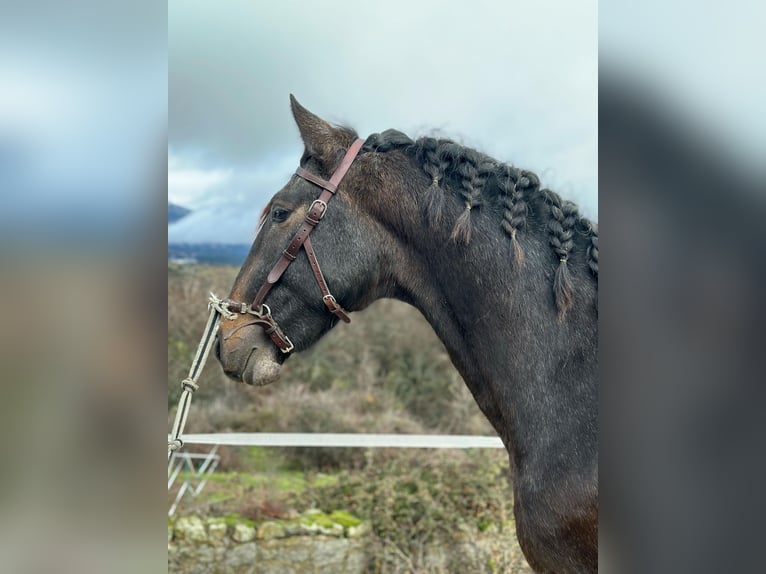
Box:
[294,449,515,572]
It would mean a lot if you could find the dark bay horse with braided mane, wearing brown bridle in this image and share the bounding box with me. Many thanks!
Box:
[216,95,598,574]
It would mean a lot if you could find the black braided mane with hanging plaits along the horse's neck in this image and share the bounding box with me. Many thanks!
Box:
[362,130,598,317]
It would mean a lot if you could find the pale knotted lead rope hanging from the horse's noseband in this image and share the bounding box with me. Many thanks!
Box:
[168,293,235,468]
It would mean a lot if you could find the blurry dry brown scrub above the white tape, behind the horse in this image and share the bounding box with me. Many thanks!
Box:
[168,266,494,454]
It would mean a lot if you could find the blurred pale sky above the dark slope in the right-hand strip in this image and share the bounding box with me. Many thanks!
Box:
[599,0,766,173]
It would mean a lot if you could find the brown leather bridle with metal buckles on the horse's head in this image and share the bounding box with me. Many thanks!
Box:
[221,138,364,353]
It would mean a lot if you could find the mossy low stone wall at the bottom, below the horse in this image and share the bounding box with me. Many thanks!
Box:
[168,511,532,574]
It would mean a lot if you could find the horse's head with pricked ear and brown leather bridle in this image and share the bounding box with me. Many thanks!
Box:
[217,96,391,385]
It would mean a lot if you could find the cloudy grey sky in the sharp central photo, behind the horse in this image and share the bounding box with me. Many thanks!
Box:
[168,0,598,242]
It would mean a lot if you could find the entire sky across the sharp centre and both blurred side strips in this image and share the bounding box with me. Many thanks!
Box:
[0,0,766,249]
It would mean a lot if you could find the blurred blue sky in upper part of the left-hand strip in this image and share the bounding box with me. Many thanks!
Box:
[0,0,167,239]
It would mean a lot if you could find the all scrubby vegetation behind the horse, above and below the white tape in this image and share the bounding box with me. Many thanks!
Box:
[168,266,527,573]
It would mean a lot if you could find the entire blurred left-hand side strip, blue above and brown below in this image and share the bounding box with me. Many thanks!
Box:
[0,0,167,572]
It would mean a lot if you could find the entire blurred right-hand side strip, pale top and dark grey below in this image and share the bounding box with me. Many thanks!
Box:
[599,2,766,572]
